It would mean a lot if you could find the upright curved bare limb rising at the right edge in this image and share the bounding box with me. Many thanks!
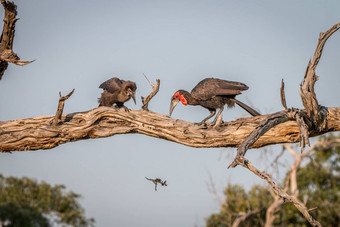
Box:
[300,22,340,130]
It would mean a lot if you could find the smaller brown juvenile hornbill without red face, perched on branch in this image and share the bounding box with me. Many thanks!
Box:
[98,77,137,111]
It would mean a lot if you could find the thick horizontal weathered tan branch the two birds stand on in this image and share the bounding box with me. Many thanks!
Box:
[0,107,340,152]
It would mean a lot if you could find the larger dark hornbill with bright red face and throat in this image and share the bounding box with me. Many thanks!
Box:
[169,78,261,125]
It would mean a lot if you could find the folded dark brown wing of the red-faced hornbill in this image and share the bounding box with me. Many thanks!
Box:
[191,78,248,100]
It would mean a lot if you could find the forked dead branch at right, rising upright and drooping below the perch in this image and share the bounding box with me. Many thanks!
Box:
[228,23,340,226]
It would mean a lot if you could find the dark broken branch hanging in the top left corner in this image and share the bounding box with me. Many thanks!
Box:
[0,0,33,80]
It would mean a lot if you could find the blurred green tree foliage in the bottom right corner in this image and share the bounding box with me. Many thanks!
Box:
[206,134,340,227]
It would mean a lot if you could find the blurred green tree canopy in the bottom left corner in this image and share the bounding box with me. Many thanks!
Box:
[0,174,94,227]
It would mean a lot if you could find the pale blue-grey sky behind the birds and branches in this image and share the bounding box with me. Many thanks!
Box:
[0,0,340,226]
